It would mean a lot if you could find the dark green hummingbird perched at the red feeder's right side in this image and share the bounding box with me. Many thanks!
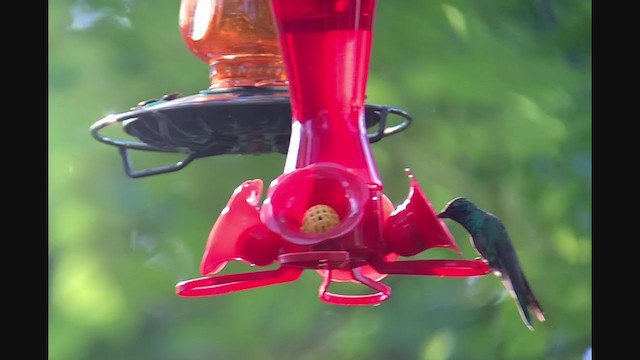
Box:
[438,197,545,330]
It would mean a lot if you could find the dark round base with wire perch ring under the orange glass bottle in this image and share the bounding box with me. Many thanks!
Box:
[90,88,413,178]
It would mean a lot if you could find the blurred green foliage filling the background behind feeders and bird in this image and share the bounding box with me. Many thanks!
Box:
[49,0,592,360]
